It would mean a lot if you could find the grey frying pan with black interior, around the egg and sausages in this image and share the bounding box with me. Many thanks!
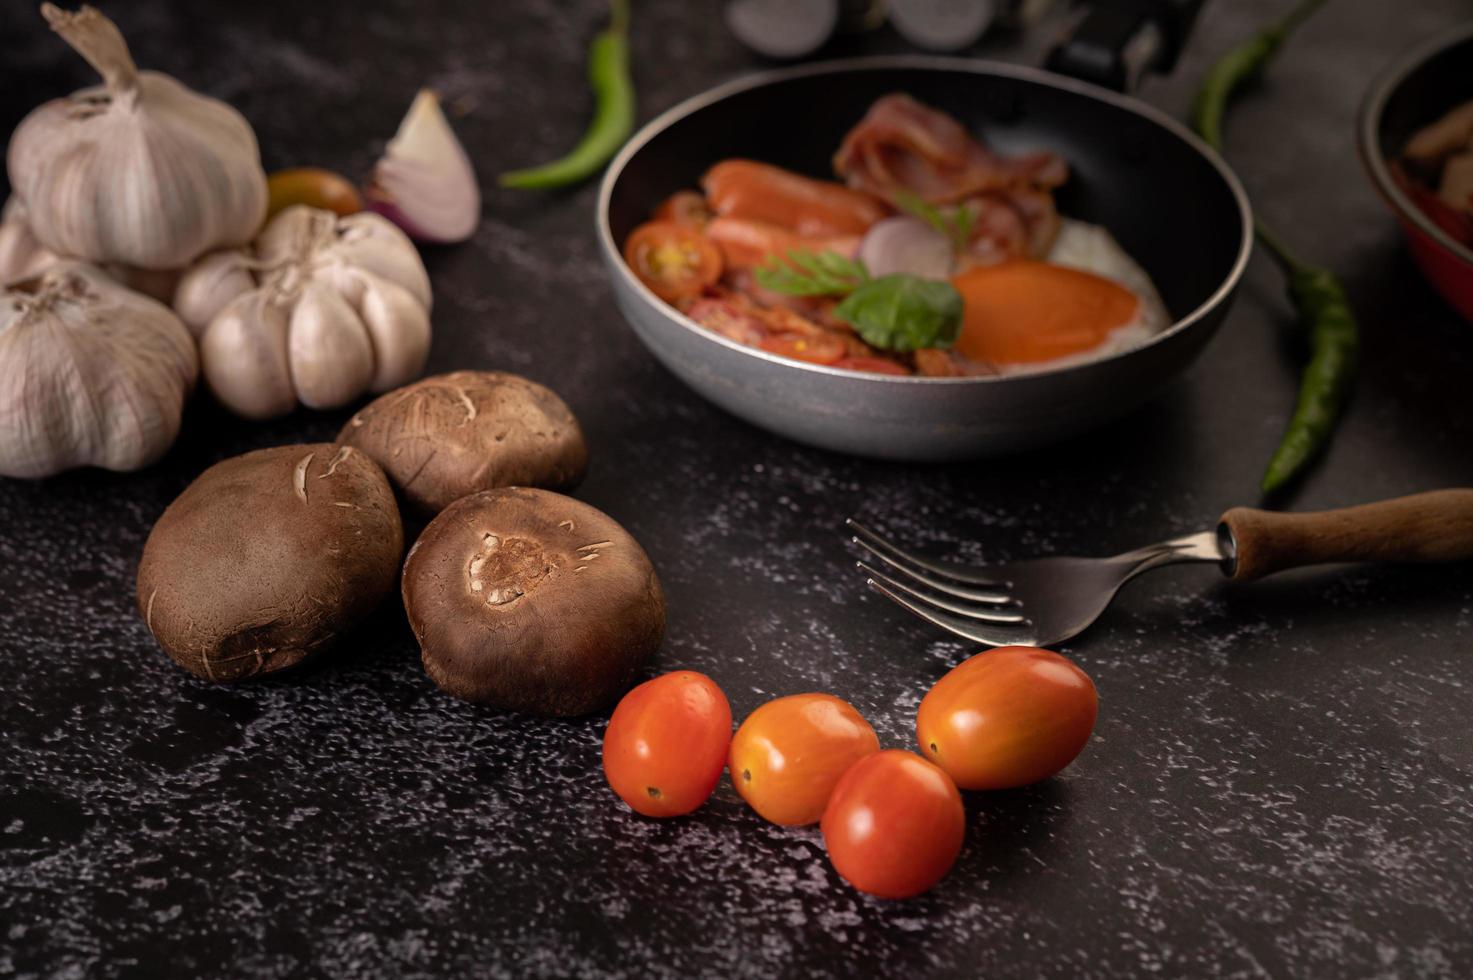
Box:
[595,56,1252,461]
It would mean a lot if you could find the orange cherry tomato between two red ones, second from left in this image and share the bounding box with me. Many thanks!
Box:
[728,694,879,827]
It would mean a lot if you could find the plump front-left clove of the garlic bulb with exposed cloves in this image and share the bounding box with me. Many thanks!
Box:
[199,289,296,419]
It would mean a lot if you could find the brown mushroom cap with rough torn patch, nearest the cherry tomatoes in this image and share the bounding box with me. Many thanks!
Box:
[404,488,664,716]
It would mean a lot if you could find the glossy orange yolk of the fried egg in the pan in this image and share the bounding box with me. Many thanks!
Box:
[952,261,1140,364]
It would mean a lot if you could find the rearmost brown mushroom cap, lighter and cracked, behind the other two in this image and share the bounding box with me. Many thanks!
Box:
[337,371,588,514]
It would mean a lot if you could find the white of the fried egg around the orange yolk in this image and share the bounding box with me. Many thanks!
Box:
[997,218,1171,374]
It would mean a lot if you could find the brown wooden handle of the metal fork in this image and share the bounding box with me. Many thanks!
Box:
[1218,489,1473,582]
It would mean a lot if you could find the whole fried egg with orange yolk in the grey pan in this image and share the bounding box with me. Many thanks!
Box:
[953,218,1171,374]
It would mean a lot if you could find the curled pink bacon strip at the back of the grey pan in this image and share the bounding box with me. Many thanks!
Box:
[834,94,1069,203]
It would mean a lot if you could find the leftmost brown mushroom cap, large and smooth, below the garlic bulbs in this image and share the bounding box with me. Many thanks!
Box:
[138,442,404,681]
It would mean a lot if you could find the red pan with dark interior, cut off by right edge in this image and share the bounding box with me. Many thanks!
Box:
[1358,24,1473,321]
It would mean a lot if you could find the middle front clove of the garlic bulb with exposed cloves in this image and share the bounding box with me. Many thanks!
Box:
[289,283,374,408]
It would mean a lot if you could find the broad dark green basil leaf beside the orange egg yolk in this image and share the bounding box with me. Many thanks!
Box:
[834,274,962,351]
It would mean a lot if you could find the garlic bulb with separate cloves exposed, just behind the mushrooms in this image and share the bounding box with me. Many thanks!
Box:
[174,205,430,419]
